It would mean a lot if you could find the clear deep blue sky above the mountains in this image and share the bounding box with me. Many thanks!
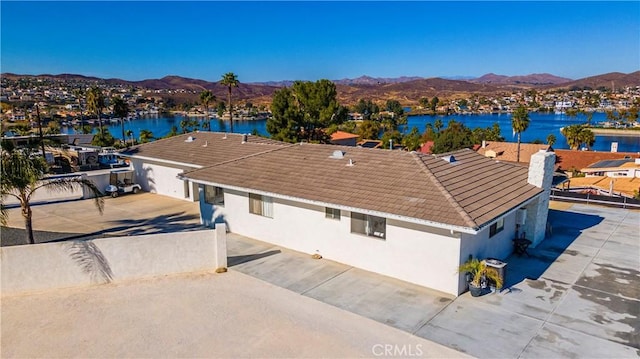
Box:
[0,0,640,82]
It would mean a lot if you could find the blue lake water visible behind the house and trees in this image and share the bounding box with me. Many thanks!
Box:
[62,113,640,152]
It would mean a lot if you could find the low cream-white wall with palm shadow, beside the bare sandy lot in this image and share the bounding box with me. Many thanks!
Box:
[0,230,220,295]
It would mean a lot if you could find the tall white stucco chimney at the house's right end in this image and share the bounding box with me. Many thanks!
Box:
[522,150,556,247]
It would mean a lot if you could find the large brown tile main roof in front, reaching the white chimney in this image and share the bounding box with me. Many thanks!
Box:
[185,144,541,229]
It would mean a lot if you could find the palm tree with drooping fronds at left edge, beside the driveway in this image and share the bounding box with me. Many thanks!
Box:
[0,150,104,244]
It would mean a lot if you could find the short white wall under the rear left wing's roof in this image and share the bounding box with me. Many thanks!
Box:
[130,158,198,201]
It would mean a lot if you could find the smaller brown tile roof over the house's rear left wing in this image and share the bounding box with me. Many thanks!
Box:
[121,132,292,168]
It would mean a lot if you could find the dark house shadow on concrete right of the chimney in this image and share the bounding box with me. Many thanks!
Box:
[504,209,603,288]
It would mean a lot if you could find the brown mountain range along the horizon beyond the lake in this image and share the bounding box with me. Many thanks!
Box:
[2,71,640,104]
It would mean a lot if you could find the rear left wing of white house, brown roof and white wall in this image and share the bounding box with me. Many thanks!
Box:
[120,132,292,201]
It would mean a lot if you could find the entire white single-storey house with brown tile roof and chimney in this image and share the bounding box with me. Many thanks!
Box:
[124,132,555,295]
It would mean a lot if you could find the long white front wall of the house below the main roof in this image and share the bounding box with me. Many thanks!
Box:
[208,189,461,295]
